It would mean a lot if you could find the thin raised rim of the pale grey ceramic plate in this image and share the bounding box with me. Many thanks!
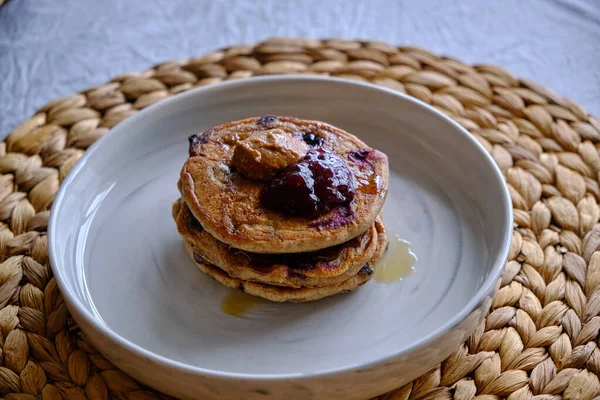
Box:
[47,74,514,381]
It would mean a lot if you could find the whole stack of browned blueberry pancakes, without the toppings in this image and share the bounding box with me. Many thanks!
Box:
[173,116,389,302]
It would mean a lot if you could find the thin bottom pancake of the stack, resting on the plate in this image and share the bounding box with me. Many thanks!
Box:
[186,219,388,303]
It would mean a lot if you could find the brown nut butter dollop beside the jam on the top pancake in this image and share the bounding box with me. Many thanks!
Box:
[232,129,308,181]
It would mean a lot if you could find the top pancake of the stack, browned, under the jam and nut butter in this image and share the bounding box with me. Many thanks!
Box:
[178,117,389,253]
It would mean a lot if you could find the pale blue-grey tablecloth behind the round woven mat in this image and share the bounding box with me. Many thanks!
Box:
[0,0,600,136]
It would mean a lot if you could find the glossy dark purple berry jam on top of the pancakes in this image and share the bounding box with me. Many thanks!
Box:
[260,148,356,218]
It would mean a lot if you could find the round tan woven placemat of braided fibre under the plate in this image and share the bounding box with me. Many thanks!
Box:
[0,39,600,400]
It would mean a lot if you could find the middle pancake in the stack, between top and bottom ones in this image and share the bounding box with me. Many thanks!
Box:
[173,199,382,288]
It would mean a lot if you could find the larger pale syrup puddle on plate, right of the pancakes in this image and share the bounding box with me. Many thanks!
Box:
[374,234,418,283]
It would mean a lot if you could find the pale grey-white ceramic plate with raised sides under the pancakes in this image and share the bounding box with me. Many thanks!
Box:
[49,77,512,399]
